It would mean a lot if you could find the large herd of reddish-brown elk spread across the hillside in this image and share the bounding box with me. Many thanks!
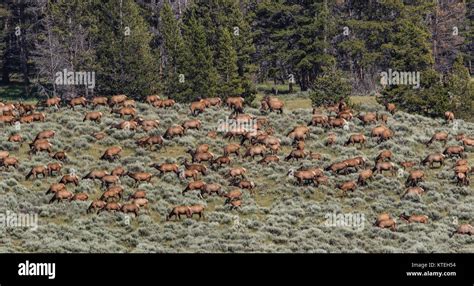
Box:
[0,95,474,237]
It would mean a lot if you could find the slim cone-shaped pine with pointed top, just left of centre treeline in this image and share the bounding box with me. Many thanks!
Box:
[178,9,217,101]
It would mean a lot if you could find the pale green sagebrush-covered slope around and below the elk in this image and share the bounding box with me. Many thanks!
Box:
[0,96,474,252]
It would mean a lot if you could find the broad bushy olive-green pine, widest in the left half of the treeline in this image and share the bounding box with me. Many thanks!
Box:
[94,0,158,98]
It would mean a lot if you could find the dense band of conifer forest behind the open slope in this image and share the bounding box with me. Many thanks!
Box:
[0,0,474,119]
